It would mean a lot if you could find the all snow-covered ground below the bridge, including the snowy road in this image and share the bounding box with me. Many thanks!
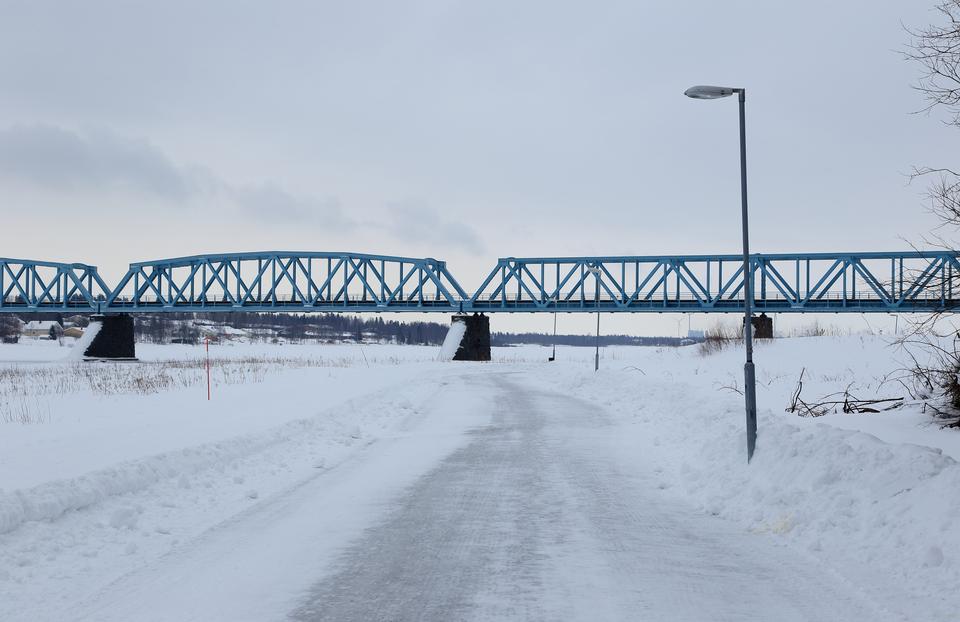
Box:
[0,336,960,621]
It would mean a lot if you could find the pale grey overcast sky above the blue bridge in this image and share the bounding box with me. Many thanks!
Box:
[0,0,960,336]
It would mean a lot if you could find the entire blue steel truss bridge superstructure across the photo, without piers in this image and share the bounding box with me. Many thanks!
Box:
[0,251,960,313]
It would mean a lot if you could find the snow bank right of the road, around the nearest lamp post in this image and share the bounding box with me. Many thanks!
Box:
[538,338,960,619]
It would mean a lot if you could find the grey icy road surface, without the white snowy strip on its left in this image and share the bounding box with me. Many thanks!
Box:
[291,375,882,622]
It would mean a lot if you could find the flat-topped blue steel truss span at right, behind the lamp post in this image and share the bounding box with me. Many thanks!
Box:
[465,251,960,313]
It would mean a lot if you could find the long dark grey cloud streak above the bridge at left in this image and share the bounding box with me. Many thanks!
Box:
[0,125,483,253]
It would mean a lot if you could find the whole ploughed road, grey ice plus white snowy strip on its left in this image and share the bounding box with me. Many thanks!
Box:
[74,371,896,621]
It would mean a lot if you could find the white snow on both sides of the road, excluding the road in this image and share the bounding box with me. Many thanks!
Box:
[0,337,960,620]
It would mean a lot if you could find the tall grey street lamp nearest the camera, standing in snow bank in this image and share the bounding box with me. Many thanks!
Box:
[683,86,757,463]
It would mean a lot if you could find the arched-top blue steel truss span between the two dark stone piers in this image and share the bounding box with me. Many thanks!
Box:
[103,252,468,312]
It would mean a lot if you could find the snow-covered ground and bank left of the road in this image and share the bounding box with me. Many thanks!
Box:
[0,346,484,622]
